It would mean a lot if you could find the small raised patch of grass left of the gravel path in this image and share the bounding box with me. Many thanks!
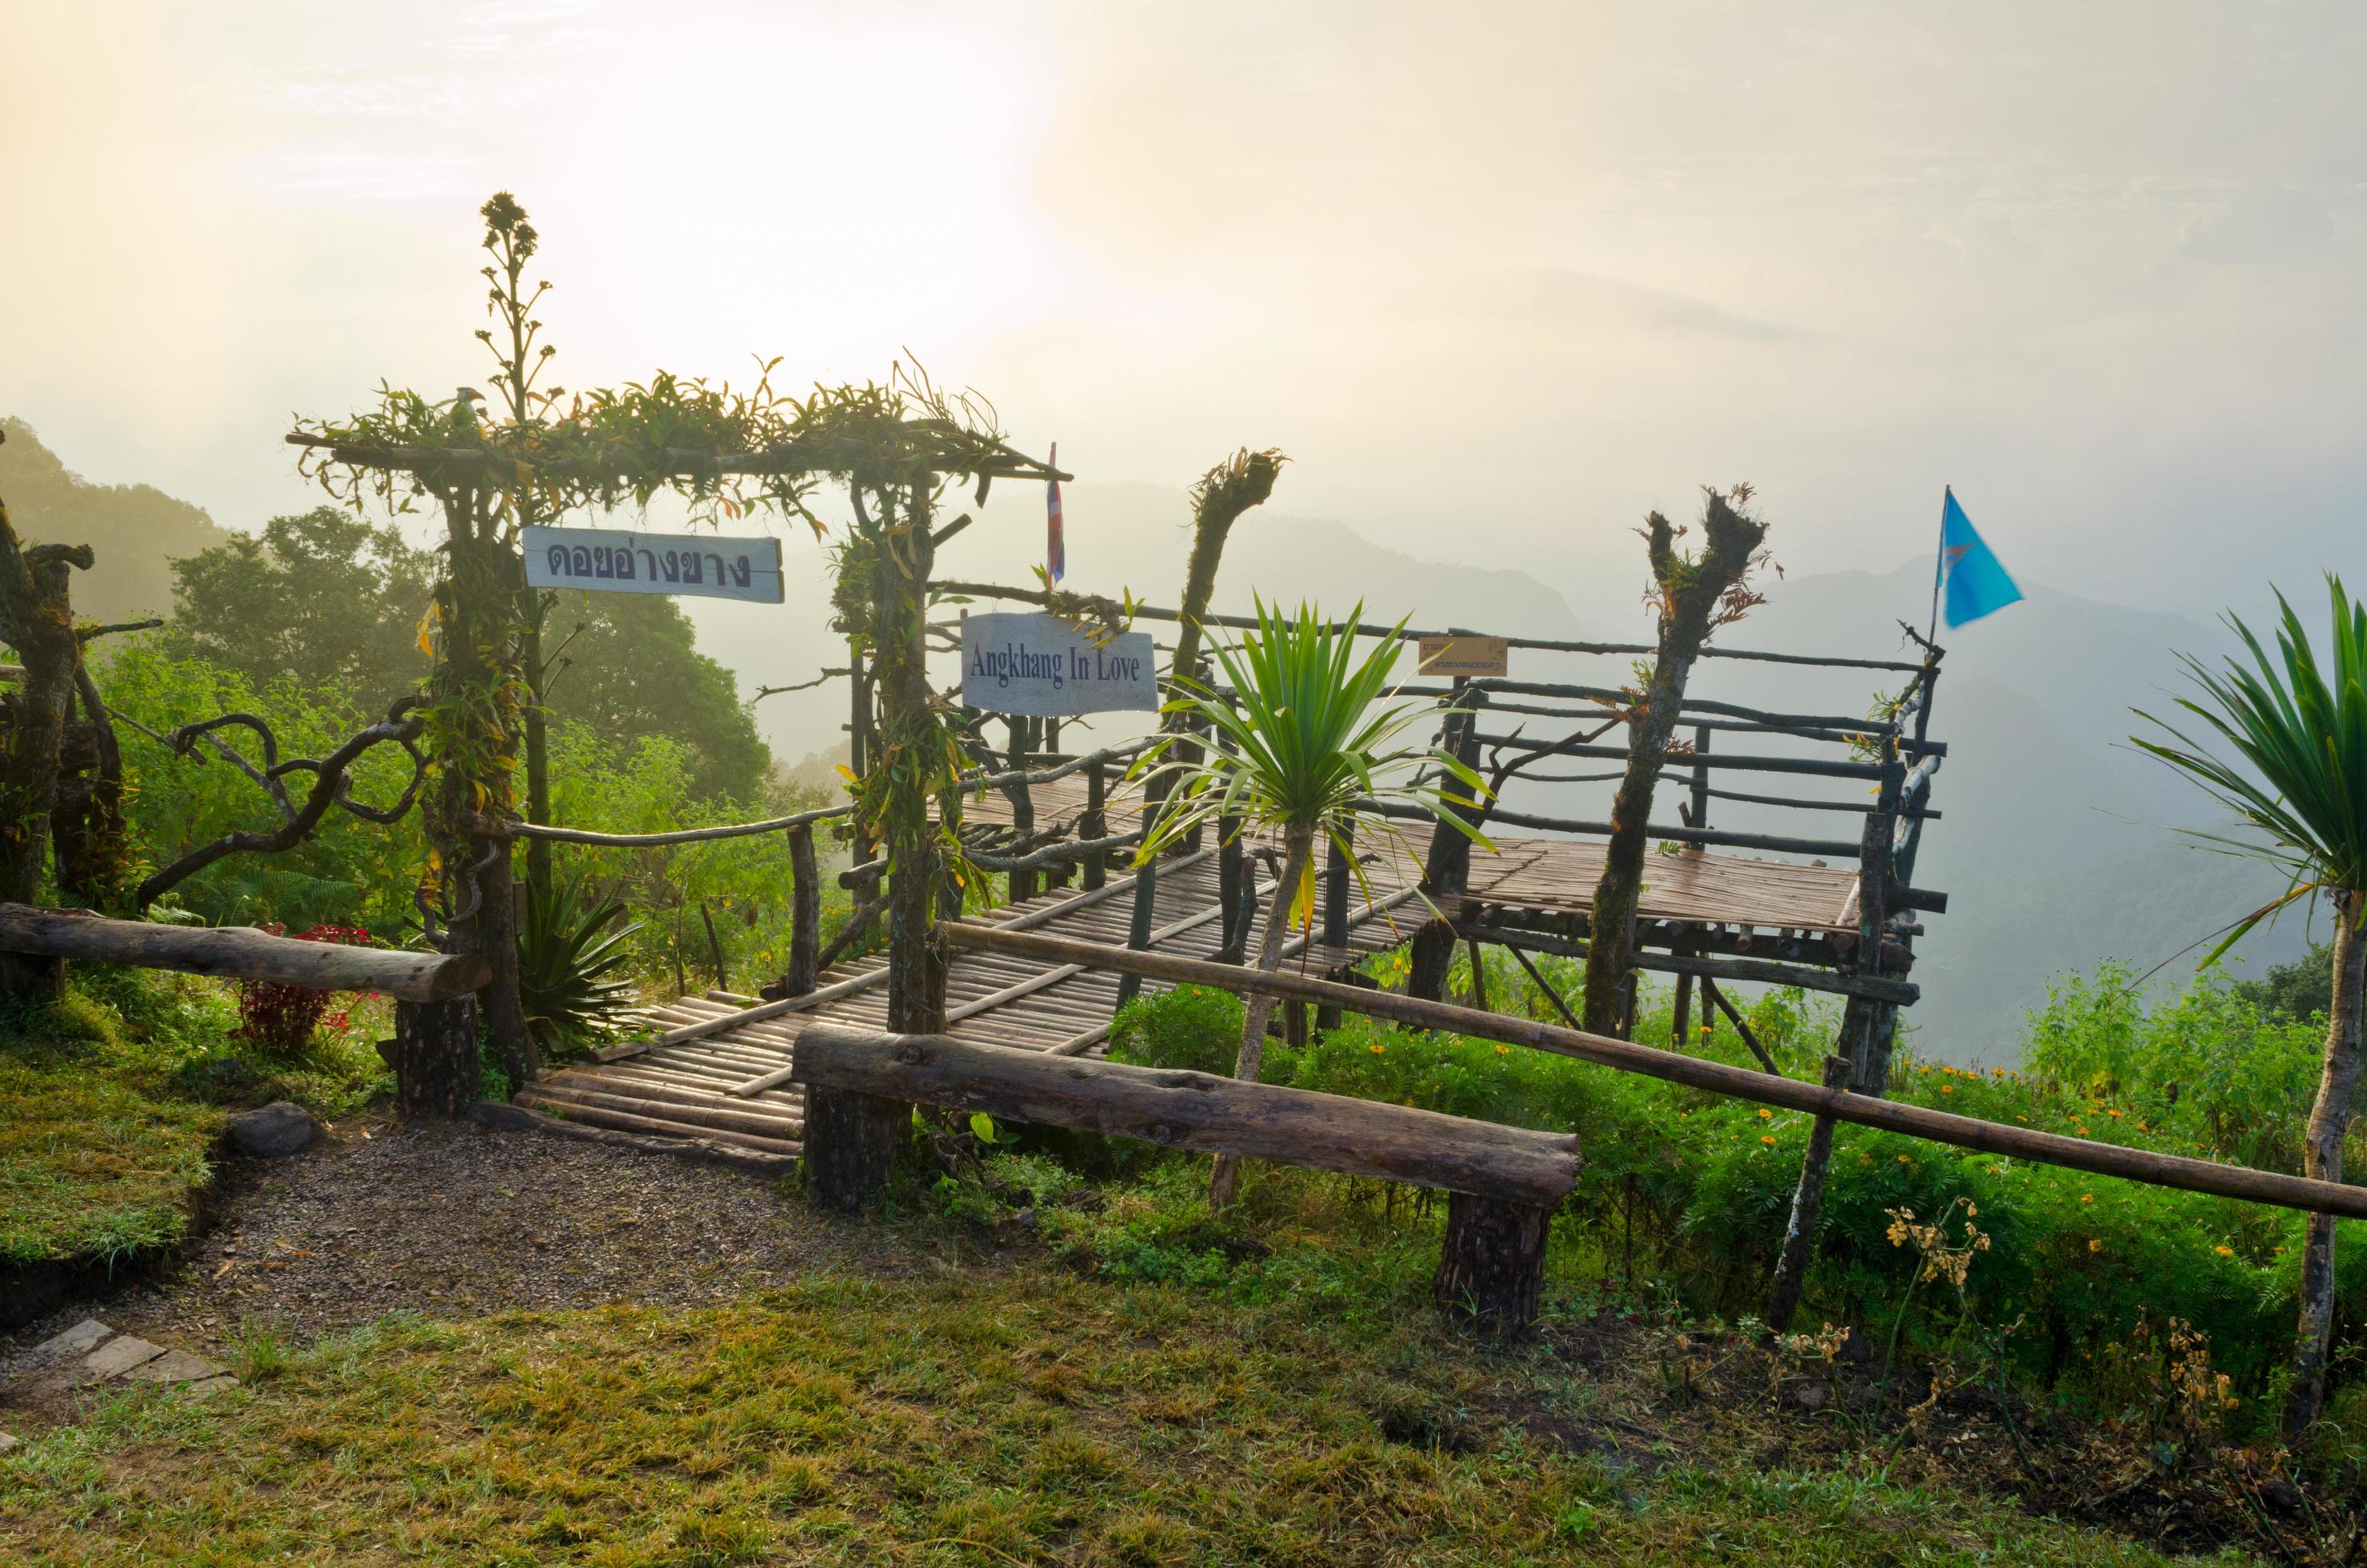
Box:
[0,1050,220,1267]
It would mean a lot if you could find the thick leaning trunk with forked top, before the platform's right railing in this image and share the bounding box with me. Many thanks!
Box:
[1586,486,1768,1035]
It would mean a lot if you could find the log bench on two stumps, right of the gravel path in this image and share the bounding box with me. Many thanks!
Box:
[790,1023,1581,1334]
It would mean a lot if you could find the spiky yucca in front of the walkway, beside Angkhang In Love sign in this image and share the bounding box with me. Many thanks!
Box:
[1134,599,1484,1208]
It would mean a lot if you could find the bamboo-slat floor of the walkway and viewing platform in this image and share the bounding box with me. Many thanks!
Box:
[518,805,1856,1156]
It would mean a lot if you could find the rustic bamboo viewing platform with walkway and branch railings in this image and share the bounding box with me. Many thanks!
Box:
[514,603,1945,1158]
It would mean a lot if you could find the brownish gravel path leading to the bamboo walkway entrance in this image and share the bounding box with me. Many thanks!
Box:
[0,1118,845,1376]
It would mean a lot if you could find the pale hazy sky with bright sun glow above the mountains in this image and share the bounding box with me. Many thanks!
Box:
[0,0,2367,625]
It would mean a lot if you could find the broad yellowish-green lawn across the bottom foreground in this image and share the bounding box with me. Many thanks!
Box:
[0,1262,2225,1568]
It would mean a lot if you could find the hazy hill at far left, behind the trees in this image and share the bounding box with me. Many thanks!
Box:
[0,419,230,621]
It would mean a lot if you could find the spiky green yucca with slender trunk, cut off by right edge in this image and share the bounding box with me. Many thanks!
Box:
[2133,575,2367,1438]
